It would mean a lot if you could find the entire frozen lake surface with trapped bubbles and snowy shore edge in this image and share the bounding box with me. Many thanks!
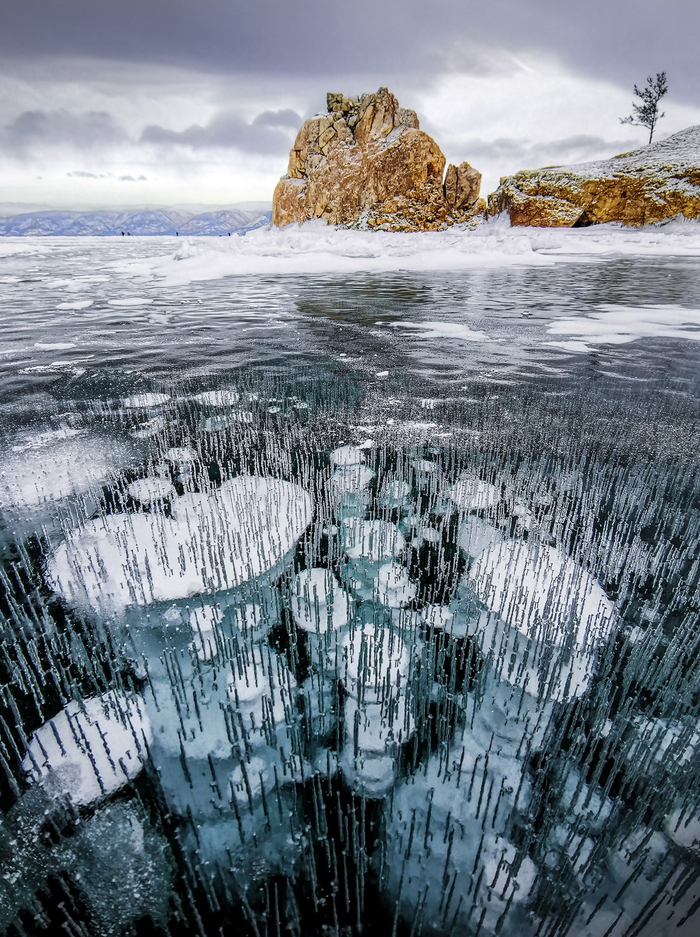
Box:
[0,225,700,937]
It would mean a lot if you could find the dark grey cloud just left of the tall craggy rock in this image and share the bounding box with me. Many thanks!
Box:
[140,111,301,154]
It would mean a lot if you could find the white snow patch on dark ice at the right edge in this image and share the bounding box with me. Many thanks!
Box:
[545,303,700,352]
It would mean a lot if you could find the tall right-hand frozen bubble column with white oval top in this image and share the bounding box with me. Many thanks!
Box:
[379,528,613,935]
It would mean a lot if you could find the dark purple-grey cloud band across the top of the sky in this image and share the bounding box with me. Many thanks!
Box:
[0,0,700,101]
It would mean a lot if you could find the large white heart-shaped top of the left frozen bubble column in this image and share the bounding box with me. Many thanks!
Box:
[47,475,312,611]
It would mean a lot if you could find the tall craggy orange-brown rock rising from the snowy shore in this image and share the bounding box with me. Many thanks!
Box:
[272,88,485,231]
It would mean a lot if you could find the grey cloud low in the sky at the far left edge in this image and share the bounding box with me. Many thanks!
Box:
[0,110,128,156]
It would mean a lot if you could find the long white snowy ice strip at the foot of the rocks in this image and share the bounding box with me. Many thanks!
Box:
[114,216,700,286]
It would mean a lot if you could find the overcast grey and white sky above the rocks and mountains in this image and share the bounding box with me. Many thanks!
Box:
[0,0,700,211]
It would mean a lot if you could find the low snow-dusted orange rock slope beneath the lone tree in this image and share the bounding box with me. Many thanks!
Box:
[488,126,700,227]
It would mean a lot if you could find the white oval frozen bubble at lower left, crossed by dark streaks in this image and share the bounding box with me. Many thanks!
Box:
[22,692,152,805]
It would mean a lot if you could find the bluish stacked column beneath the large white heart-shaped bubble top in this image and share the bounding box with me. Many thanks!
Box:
[134,600,309,891]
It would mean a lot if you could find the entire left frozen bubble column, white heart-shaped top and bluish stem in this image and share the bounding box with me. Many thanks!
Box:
[47,475,311,888]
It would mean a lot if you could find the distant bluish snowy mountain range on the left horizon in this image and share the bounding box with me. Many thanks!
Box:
[0,208,270,237]
